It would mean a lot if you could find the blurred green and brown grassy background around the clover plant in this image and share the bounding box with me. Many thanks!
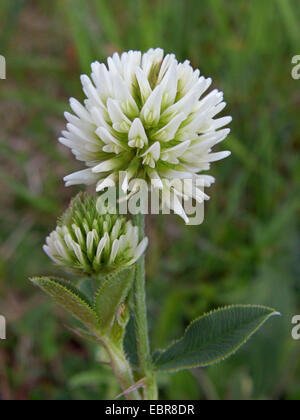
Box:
[0,0,300,400]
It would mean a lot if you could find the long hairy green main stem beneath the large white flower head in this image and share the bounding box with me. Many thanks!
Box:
[134,213,158,400]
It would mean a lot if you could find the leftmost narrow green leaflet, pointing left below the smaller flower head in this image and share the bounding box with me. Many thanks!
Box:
[31,277,99,331]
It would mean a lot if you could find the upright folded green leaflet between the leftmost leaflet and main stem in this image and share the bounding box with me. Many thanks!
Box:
[95,268,135,331]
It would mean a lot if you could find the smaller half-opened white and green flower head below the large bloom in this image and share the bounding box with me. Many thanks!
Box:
[43,194,148,275]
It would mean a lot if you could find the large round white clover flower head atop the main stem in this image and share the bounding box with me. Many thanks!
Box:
[59,48,232,221]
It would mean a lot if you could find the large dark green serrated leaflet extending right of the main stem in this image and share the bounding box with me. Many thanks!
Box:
[153,305,280,372]
